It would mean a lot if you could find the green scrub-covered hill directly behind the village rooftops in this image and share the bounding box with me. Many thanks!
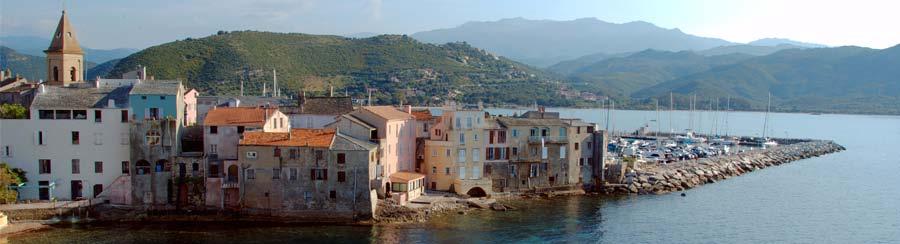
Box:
[107,31,579,106]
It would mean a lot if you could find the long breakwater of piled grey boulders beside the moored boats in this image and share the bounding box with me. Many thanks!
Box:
[602,140,845,194]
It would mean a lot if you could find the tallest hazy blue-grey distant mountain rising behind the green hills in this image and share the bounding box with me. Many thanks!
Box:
[412,18,735,67]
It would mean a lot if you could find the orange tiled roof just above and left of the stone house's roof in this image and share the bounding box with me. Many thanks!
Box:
[203,107,278,126]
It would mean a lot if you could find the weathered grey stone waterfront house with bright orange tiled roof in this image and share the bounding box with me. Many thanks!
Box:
[237,129,377,221]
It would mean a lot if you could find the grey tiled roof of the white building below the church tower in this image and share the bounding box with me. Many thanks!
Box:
[31,86,131,108]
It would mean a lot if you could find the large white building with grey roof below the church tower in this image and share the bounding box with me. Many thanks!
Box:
[0,83,131,200]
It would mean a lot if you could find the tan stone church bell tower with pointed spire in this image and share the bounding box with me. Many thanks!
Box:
[44,10,84,86]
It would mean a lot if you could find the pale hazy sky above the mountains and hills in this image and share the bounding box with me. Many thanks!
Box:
[0,0,900,48]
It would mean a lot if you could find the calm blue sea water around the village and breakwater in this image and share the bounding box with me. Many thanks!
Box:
[9,109,900,243]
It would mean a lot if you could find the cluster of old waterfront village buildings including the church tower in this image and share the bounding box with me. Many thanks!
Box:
[0,12,620,225]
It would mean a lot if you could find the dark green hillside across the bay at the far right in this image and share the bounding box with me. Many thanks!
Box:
[633,46,900,114]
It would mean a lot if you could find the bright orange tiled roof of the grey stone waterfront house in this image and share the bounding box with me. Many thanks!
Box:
[240,129,335,147]
